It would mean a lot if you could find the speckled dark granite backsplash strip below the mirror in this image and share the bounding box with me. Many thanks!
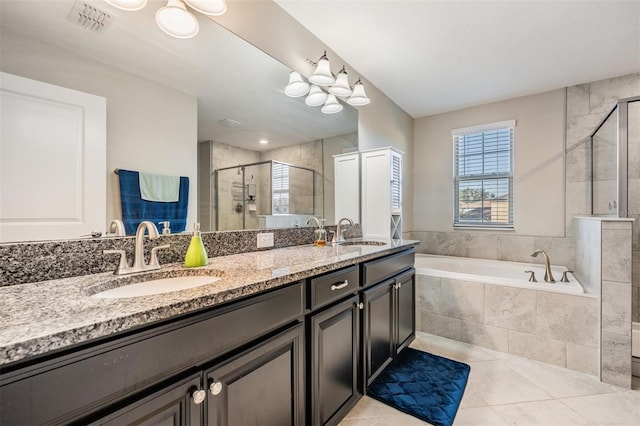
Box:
[0,224,362,286]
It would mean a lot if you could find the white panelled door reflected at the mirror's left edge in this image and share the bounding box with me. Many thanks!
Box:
[0,73,106,242]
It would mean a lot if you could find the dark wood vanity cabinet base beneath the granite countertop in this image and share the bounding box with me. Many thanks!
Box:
[0,249,415,426]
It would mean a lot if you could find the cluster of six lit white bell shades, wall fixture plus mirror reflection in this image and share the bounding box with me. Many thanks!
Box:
[284,51,371,114]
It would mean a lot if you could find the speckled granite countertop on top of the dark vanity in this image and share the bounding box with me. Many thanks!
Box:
[0,240,418,366]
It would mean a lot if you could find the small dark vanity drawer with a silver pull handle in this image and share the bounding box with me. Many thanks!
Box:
[309,265,360,310]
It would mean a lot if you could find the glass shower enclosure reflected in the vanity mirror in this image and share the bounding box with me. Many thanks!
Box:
[213,160,316,231]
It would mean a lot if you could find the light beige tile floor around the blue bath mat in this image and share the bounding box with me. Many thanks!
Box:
[341,332,640,426]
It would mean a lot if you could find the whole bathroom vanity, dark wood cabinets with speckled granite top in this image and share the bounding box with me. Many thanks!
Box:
[0,240,416,425]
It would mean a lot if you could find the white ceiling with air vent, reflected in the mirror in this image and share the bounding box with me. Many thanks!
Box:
[0,0,358,151]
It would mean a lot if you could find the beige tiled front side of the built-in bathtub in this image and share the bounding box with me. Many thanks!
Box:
[416,275,600,375]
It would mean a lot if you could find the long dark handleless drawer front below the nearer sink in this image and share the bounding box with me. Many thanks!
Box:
[0,282,304,425]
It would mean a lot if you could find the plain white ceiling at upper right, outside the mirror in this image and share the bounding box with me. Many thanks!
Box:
[275,0,640,118]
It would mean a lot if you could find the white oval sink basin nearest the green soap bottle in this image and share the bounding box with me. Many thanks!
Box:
[92,275,220,299]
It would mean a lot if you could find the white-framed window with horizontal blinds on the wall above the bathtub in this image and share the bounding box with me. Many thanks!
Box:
[452,120,515,228]
